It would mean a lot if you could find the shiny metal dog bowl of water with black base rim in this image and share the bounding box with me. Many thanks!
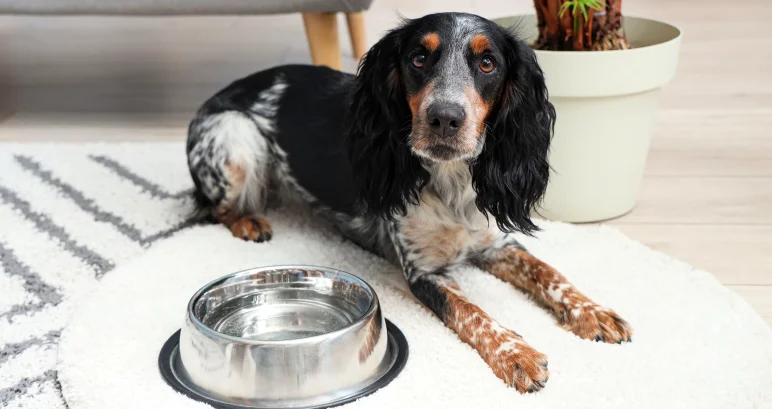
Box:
[159,266,408,408]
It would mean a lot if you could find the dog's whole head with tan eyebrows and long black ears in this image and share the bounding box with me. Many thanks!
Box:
[348,13,555,233]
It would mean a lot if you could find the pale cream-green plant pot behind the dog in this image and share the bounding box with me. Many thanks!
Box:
[494,15,681,222]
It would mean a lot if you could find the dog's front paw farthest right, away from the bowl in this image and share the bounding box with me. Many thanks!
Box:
[561,303,633,344]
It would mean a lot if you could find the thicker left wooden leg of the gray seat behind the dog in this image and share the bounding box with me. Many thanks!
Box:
[303,13,341,70]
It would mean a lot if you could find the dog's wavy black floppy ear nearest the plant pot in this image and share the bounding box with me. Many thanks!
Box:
[472,29,555,234]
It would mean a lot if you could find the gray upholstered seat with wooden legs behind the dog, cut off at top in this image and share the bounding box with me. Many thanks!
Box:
[0,0,373,69]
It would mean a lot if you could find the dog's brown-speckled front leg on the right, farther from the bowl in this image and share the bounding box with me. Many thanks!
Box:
[477,235,633,343]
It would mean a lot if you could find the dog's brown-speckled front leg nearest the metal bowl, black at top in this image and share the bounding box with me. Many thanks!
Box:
[410,274,549,393]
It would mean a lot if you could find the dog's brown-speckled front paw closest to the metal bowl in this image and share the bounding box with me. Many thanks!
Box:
[487,333,549,393]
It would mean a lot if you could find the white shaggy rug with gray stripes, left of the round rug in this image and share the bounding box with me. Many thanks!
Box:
[0,142,192,409]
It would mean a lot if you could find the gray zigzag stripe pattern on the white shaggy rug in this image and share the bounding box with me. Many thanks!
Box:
[0,151,202,407]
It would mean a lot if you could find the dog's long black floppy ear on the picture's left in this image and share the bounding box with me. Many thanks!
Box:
[346,19,429,218]
